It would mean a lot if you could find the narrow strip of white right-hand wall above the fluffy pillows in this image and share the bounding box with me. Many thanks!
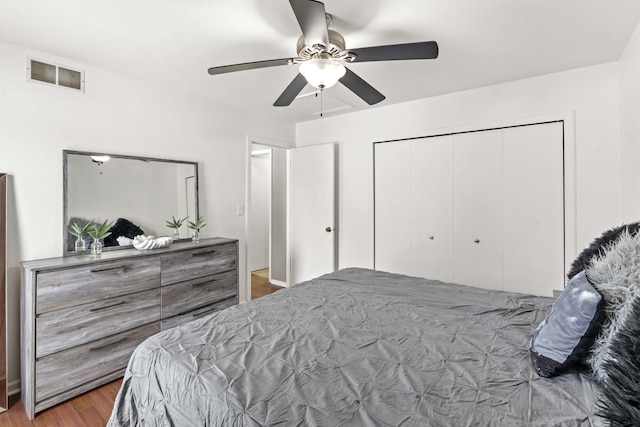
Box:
[620,20,640,222]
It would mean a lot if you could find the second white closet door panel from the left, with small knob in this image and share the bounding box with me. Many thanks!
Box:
[410,135,453,282]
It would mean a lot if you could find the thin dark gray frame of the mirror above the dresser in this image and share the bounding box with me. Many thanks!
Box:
[62,150,200,256]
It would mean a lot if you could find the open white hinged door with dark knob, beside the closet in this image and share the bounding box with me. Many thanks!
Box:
[289,144,337,284]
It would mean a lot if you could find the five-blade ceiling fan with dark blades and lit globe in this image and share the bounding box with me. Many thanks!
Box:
[209,0,438,107]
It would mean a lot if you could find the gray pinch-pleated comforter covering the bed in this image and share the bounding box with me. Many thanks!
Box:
[109,269,602,427]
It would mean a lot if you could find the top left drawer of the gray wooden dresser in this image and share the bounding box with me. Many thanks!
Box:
[36,258,160,314]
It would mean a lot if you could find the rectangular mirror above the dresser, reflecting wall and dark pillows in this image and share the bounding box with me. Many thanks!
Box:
[63,150,198,255]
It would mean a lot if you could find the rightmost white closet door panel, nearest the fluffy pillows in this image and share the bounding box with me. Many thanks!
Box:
[503,123,564,296]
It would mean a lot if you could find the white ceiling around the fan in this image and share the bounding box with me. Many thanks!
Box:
[0,0,640,122]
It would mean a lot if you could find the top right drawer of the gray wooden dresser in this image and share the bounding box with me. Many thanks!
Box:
[162,243,238,286]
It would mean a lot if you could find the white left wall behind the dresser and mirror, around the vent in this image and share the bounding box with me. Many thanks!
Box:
[0,42,293,392]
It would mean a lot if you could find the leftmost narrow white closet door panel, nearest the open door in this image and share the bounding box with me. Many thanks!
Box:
[374,141,411,274]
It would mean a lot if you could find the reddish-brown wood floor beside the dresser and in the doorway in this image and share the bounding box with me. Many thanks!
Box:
[0,274,282,427]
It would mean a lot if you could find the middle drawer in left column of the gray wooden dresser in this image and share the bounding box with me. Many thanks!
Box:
[36,288,160,358]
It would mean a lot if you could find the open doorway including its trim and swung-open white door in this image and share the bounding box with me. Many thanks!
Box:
[245,137,337,300]
